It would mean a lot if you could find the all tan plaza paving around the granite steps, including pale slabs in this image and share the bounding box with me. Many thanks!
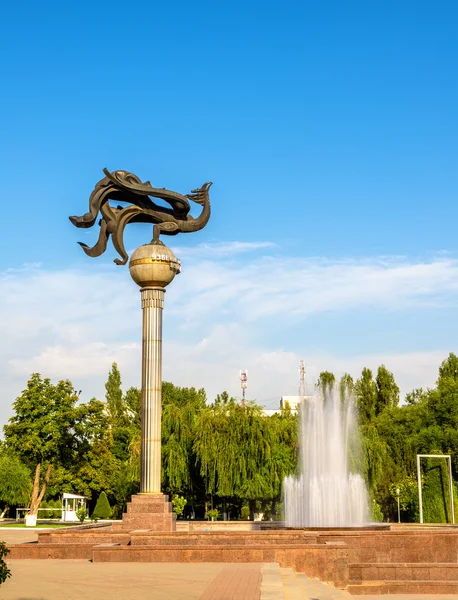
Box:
[0,529,458,600]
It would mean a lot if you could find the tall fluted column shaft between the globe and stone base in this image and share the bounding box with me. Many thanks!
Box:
[140,287,165,494]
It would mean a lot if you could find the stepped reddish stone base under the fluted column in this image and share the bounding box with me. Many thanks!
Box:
[114,494,177,531]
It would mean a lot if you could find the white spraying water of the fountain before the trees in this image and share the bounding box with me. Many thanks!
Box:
[283,386,369,527]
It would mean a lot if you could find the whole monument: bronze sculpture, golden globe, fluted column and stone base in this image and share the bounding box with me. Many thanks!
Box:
[70,169,212,531]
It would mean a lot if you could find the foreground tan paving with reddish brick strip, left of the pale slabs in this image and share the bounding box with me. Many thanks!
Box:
[0,560,261,600]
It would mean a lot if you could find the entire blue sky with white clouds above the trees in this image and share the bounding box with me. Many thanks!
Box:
[0,0,458,421]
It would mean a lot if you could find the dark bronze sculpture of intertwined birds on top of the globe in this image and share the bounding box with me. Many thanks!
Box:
[69,169,212,265]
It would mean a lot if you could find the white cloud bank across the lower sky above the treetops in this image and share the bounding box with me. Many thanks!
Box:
[0,248,458,422]
